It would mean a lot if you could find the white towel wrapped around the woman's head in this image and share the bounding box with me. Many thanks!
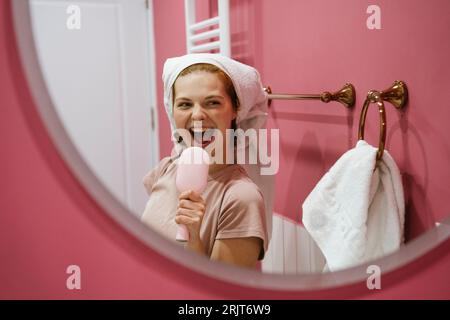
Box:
[163,53,268,153]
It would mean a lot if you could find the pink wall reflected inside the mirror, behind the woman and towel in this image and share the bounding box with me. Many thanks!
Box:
[155,0,450,240]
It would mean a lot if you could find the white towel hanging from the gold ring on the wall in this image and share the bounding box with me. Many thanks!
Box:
[303,140,405,271]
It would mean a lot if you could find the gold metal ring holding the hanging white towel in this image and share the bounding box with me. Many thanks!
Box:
[358,91,386,162]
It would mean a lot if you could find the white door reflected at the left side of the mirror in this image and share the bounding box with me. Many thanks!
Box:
[30,0,159,215]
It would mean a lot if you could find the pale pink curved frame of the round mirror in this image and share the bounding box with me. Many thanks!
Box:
[11,0,450,291]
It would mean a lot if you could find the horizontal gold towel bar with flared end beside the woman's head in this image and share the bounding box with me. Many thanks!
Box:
[264,83,355,108]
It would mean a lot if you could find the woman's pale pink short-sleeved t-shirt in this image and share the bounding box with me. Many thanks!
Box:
[141,156,268,259]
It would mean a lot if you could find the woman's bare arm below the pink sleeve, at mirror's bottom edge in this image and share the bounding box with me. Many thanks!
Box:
[211,237,263,268]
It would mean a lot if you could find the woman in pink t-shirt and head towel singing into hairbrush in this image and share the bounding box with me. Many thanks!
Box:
[142,54,268,267]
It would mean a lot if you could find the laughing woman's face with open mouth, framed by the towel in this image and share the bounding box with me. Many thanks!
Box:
[173,71,236,155]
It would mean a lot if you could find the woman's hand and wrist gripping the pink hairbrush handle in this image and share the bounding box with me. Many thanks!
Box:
[175,190,206,254]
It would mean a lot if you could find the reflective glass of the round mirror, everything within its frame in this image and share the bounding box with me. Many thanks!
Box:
[29,0,450,274]
